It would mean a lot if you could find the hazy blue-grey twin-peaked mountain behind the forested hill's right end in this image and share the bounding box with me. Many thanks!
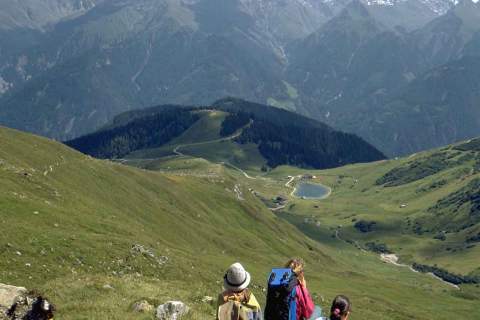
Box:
[288,1,480,155]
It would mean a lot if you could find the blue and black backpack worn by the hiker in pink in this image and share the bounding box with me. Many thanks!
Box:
[265,268,298,320]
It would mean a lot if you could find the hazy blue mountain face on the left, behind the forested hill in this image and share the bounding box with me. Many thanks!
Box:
[0,0,279,139]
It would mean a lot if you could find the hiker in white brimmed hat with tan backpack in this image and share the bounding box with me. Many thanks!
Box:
[217,262,263,320]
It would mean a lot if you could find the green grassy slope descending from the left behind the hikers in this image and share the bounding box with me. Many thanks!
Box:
[0,128,478,320]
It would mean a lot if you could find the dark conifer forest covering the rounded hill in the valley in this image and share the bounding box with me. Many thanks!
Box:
[66,99,384,168]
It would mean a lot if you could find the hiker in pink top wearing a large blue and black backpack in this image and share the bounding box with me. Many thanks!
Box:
[265,259,321,320]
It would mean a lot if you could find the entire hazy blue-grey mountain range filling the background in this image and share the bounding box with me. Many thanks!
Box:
[0,0,480,156]
